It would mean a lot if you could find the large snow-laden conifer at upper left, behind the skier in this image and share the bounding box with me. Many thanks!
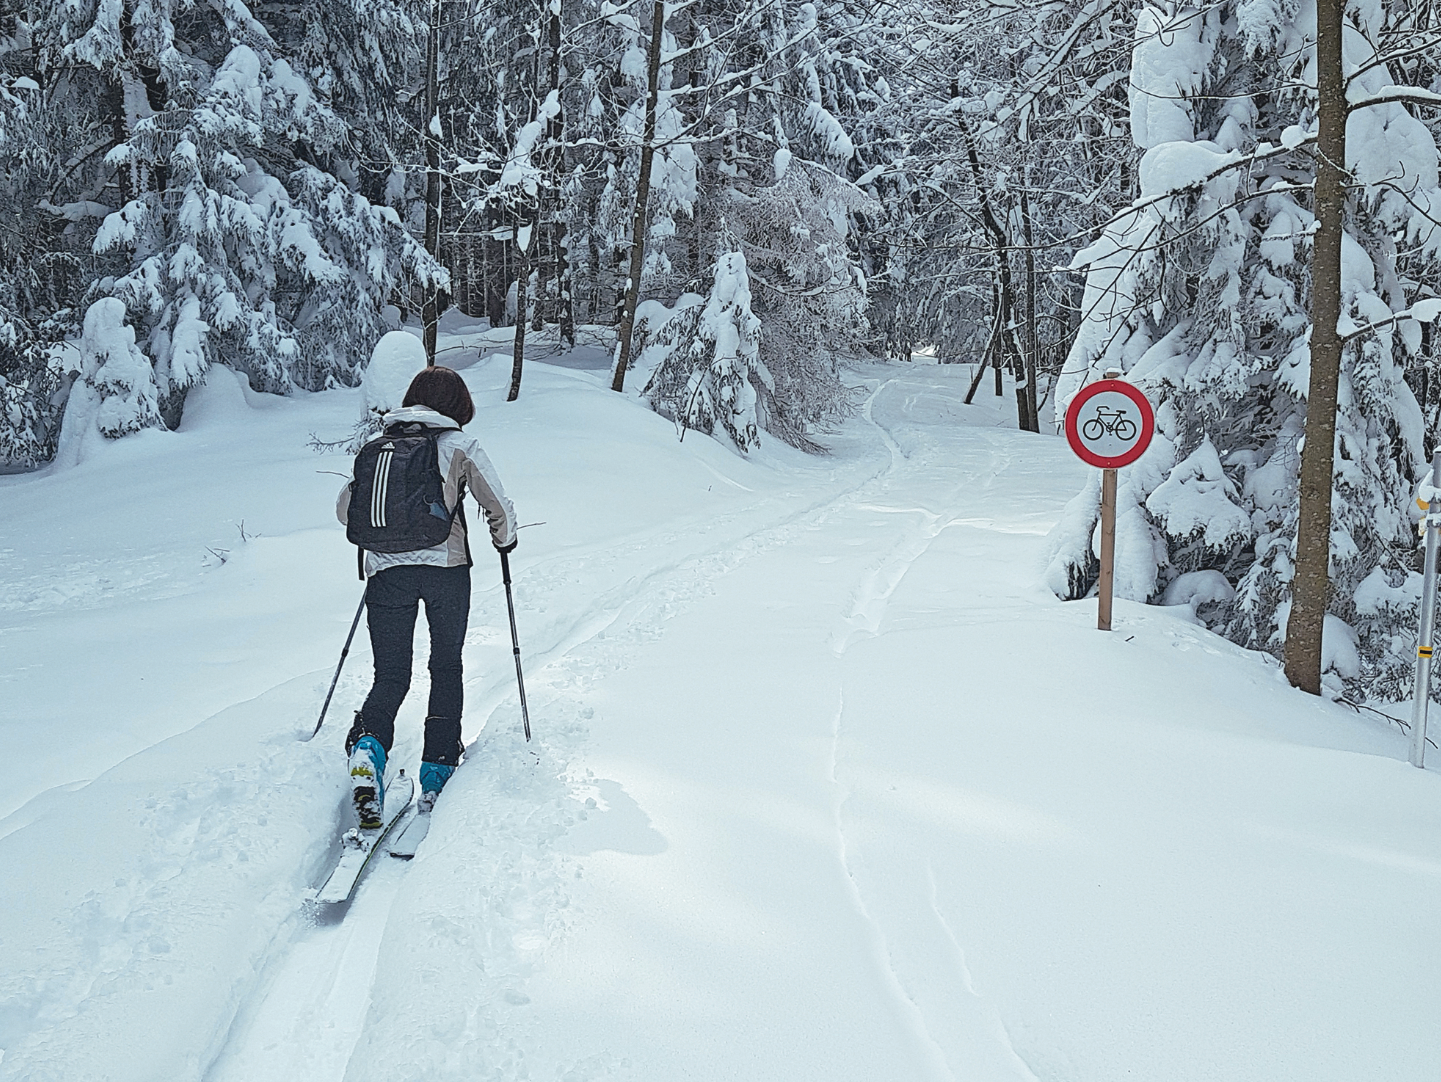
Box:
[37,0,444,431]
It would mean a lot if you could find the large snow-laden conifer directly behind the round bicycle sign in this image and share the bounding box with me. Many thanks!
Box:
[1048,0,1441,696]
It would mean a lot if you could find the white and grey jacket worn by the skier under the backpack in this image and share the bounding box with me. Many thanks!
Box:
[336,406,516,578]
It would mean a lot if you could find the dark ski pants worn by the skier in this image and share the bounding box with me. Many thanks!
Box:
[346,563,470,766]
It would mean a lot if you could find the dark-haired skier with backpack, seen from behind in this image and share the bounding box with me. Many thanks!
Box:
[336,366,516,827]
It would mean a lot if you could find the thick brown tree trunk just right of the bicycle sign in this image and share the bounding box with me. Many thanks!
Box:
[1285,0,1346,694]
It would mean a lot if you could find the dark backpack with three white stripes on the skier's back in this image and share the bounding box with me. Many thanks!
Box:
[346,422,464,552]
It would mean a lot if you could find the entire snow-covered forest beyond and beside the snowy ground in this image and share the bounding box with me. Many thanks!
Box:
[0,0,1441,699]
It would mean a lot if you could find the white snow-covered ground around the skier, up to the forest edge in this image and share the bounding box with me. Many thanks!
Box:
[0,328,1441,1082]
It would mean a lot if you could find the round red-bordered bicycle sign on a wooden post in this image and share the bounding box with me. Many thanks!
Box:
[1066,372,1156,631]
